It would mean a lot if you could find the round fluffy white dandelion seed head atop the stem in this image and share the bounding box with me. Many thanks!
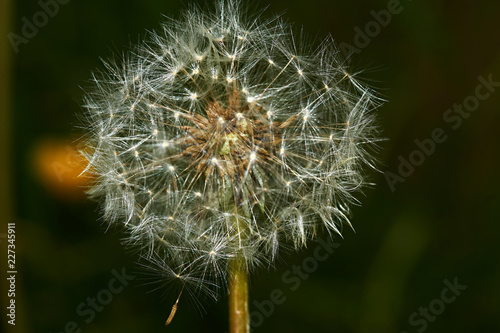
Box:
[80,1,380,295]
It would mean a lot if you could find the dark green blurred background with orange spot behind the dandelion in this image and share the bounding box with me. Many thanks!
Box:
[0,0,500,333]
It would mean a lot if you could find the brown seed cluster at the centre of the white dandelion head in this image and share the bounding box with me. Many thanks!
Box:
[174,82,282,201]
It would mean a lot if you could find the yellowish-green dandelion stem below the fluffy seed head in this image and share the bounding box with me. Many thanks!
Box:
[229,250,250,333]
